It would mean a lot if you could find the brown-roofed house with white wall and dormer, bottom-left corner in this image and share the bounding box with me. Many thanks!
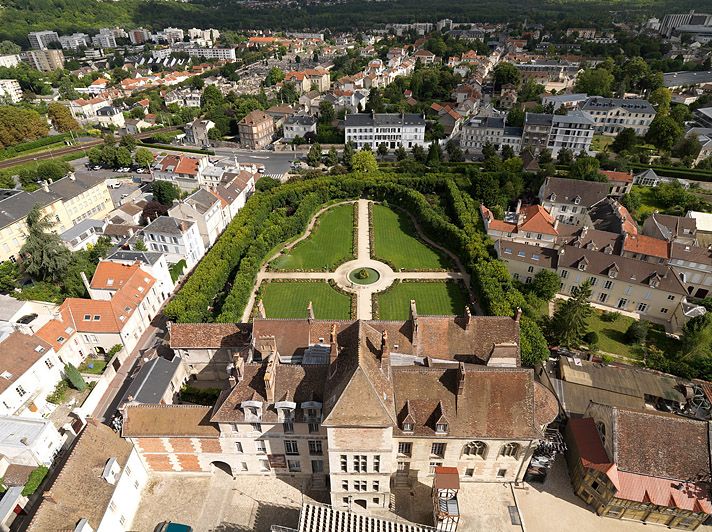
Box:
[27,420,148,532]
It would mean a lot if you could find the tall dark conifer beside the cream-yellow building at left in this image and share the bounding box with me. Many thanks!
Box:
[20,205,71,282]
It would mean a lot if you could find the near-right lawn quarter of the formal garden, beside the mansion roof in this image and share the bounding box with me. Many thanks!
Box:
[376,281,465,320]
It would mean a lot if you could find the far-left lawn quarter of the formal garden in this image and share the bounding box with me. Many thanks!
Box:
[271,204,354,270]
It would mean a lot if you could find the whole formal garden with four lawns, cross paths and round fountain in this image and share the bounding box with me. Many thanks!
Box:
[243,199,472,321]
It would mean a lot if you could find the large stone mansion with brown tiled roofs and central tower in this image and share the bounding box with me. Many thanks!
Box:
[122,312,558,508]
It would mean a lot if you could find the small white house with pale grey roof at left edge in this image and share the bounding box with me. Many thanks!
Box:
[0,416,65,467]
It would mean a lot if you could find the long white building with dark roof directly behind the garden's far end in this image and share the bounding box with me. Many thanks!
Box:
[345,113,425,151]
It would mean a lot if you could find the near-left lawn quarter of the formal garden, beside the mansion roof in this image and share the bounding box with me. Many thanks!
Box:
[260,281,351,320]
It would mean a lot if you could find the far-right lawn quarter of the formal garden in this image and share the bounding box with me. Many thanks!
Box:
[371,205,452,270]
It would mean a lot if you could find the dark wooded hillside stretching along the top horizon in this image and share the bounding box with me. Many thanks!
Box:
[0,0,700,46]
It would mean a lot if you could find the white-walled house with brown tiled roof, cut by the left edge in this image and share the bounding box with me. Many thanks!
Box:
[0,331,64,418]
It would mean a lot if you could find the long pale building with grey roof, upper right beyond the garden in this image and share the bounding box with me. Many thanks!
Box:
[581,96,656,136]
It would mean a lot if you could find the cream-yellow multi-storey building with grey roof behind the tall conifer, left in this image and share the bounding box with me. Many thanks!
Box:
[0,174,113,262]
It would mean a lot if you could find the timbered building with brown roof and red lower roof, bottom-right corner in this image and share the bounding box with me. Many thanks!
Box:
[566,403,712,530]
